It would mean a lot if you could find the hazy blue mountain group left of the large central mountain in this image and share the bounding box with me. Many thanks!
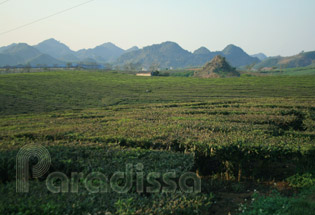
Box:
[0,39,130,67]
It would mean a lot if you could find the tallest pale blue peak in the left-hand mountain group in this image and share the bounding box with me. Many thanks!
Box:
[34,39,80,62]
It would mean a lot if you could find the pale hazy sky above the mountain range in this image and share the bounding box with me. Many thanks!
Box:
[0,0,315,56]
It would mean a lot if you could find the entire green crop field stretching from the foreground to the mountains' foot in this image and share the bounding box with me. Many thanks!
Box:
[0,71,315,214]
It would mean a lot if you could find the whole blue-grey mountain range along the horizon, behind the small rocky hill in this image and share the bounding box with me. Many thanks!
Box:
[0,39,315,69]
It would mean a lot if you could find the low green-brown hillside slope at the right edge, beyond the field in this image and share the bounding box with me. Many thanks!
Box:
[254,51,315,69]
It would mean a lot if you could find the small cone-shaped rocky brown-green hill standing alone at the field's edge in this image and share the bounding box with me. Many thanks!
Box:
[194,55,240,78]
